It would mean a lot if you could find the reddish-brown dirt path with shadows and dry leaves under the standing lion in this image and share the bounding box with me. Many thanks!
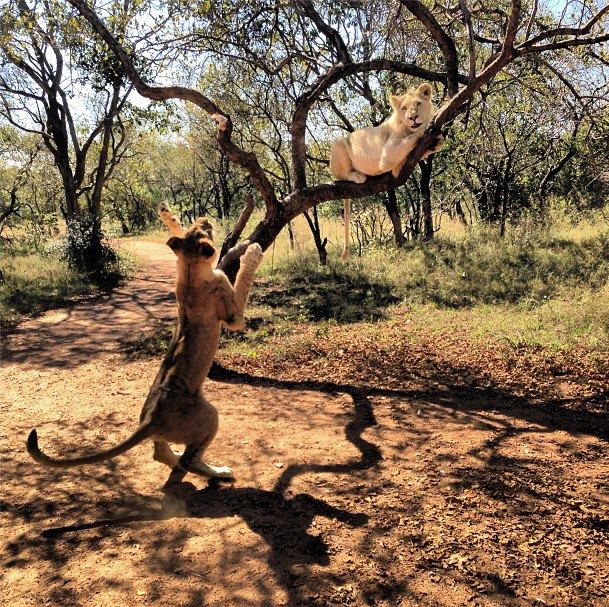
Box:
[0,241,609,607]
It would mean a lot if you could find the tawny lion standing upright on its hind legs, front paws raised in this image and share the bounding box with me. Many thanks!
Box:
[27,205,263,481]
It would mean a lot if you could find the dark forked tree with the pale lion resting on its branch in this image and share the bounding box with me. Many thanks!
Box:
[60,0,609,275]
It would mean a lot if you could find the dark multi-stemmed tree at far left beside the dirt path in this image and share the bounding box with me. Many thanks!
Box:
[0,0,131,277]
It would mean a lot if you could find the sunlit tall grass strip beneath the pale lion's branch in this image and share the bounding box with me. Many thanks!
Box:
[256,218,609,349]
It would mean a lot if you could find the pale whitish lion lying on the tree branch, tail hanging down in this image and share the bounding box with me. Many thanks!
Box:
[330,83,444,260]
